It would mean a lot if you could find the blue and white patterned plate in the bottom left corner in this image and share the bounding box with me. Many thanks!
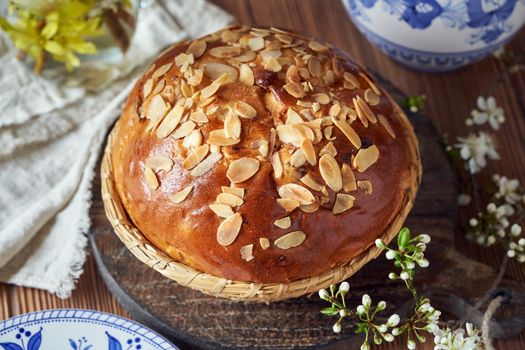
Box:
[0,309,178,350]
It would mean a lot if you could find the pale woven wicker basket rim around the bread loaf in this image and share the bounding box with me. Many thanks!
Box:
[101,102,422,302]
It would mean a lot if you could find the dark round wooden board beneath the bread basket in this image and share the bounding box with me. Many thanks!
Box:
[90,77,525,349]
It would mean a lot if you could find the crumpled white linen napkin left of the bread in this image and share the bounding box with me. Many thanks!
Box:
[0,0,232,297]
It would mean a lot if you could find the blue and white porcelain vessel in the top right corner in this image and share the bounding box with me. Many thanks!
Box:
[343,0,525,72]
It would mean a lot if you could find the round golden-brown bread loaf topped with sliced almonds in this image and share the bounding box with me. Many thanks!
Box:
[111,26,420,283]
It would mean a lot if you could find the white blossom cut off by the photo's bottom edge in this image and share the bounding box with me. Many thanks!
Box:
[434,323,482,350]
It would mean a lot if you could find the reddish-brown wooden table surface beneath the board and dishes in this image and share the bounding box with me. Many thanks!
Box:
[0,0,525,350]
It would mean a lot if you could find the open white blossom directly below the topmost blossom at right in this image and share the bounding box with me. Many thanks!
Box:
[455,131,499,174]
